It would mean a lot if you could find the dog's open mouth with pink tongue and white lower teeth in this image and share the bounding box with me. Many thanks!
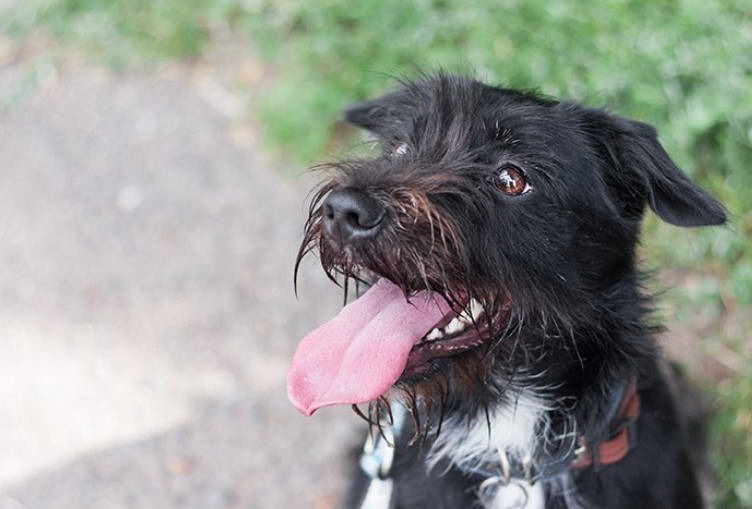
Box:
[287,278,506,415]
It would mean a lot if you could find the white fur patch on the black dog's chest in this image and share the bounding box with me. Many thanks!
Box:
[429,392,550,509]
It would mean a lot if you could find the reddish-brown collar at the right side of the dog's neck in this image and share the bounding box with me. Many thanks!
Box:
[573,379,640,468]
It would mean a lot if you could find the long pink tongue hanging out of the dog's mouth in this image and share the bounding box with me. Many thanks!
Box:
[287,279,451,415]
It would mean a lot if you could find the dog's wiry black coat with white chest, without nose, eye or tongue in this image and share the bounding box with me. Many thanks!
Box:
[296,73,725,509]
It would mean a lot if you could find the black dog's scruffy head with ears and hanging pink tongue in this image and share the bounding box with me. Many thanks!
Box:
[289,74,725,424]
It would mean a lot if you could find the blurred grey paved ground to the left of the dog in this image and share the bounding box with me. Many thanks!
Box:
[0,47,357,509]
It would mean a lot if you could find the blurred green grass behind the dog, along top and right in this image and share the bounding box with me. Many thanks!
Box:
[0,0,752,508]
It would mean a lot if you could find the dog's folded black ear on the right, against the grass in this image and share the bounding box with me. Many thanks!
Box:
[588,110,726,226]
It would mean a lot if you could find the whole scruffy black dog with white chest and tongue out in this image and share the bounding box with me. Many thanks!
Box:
[288,73,725,509]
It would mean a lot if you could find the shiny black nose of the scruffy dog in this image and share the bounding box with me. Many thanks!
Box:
[323,188,385,243]
